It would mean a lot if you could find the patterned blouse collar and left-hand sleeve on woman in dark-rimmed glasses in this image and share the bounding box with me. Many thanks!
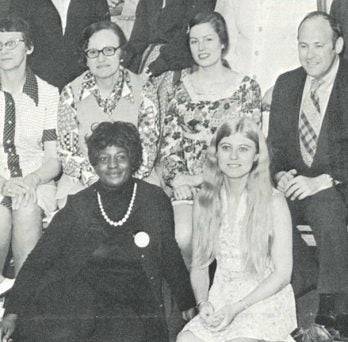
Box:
[58,67,134,184]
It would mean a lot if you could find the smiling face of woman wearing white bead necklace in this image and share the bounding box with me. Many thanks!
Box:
[94,146,132,188]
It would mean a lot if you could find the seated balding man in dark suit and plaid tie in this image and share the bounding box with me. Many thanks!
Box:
[269,12,348,332]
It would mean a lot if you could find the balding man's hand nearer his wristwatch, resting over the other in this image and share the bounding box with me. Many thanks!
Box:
[285,175,332,201]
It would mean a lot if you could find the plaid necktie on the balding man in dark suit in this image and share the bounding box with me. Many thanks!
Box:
[298,79,321,167]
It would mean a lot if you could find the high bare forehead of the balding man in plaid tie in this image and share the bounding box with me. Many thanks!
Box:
[298,17,333,42]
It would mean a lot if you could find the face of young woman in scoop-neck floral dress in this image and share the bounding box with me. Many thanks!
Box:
[189,23,223,67]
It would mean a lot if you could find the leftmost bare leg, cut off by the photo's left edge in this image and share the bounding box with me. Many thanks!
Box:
[0,204,12,282]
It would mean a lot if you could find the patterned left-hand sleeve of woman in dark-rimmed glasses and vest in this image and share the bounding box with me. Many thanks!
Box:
[58,85,94,184]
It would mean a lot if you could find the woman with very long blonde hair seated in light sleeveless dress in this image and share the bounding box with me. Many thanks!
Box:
[177,118,296,342]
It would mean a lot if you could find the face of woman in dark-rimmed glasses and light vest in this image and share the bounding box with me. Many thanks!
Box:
[87,30,121,79]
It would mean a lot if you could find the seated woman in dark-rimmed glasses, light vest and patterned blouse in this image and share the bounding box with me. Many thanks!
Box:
[57,21,150,207]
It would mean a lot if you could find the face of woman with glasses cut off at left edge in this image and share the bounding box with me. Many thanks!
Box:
[0,32,33,72]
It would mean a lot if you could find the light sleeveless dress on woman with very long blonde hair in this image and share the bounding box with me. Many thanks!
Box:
[184,194,296,342]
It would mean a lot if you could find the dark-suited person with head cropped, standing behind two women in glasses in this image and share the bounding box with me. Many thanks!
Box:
[10,0,110,90]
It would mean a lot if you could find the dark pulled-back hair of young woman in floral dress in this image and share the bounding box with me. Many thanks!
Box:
[189,12,230,57]
